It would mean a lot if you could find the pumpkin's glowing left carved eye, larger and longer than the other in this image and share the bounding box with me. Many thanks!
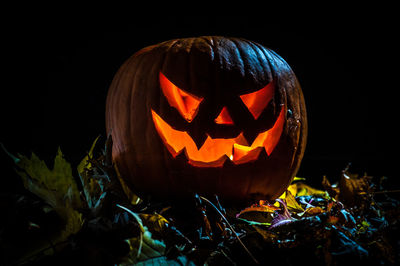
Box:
[160,72,203,123]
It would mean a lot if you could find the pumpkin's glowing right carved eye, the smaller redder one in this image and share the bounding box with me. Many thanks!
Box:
[240,82,275,119]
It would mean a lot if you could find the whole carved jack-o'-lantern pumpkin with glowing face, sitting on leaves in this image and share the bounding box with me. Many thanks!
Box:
[106,36,307,200]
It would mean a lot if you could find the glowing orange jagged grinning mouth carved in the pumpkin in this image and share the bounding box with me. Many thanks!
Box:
[151,107,285,167]
